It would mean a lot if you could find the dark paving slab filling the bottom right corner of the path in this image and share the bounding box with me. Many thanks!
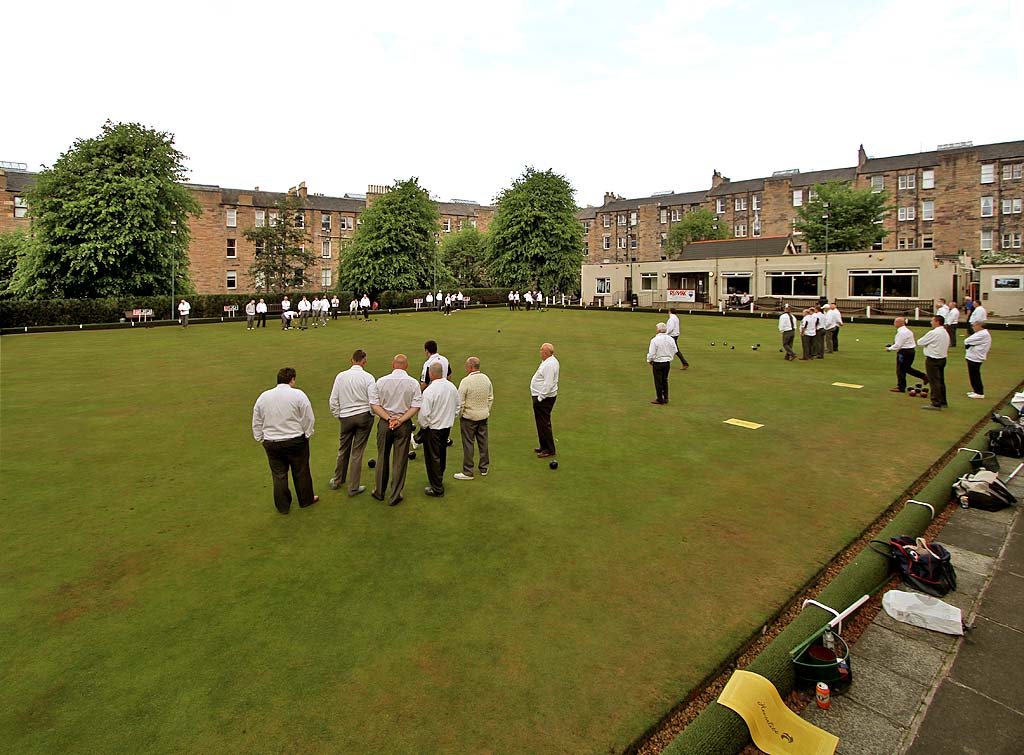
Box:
[906,680,1024,755]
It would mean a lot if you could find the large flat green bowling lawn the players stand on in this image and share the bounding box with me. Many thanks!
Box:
[0,308,1024,754]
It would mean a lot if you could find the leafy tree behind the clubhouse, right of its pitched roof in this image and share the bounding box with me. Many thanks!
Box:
[797,181,893,252]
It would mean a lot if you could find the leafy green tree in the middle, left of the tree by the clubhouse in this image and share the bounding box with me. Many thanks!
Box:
[338,177,440,296]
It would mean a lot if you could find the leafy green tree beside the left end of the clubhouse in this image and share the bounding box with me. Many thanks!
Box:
[488,167,584,291]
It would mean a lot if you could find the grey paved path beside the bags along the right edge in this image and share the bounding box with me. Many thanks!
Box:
[804,458,1024,755]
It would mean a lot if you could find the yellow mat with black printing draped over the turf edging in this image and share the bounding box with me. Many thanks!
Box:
[718,671,839,755]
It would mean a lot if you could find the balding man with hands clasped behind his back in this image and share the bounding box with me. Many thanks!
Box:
[370,353,423,506]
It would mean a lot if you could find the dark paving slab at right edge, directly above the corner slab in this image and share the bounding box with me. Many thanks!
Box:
[949,617,1024,714]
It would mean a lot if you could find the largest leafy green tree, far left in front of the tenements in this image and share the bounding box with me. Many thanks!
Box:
[14,121,201,298]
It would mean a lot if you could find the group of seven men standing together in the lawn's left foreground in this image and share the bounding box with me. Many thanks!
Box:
[252,340,559,514]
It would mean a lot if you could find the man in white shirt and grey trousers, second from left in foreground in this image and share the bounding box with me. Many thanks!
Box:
[328,348,376,497]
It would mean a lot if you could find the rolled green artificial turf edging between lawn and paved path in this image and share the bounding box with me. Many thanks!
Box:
[663,405,1016,755]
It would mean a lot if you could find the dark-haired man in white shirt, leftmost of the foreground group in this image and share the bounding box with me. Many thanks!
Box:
[253,367,319,514]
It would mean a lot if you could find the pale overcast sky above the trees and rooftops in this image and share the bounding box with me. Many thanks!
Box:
[0,0,1024,205]
